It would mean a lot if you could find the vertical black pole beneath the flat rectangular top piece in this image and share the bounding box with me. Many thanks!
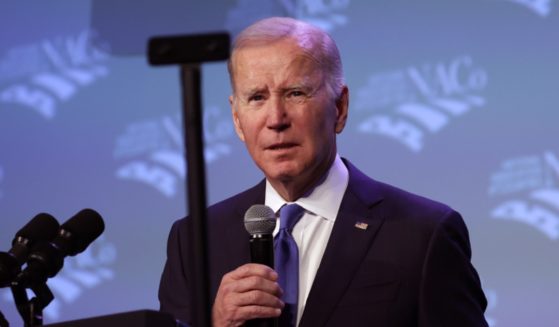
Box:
[181,63,211,327]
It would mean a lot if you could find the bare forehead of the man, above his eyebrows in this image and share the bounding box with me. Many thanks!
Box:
[231,39,322,87]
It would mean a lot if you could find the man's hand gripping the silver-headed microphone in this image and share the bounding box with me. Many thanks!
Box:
[212,263,284,326]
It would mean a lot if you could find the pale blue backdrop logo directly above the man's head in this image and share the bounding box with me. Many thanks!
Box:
[225,0,350,31]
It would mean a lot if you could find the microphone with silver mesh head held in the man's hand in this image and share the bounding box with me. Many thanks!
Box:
[245,204,278,327]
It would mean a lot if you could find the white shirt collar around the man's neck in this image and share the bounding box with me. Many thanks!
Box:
[265,155,349,221]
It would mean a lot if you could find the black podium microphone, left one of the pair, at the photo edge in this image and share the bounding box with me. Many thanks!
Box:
[0,213,60,287]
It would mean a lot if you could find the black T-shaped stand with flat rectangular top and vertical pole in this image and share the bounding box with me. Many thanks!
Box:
[148,33,229,327]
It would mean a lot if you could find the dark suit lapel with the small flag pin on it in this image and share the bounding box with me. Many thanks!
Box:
[299,162,384,327]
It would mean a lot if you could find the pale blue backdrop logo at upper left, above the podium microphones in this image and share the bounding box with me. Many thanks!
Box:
[0,31,108,119]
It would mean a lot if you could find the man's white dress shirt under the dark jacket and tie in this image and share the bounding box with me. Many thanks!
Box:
[265,155,349,325]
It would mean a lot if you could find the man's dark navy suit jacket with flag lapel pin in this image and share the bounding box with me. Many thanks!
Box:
[159,161,487,327]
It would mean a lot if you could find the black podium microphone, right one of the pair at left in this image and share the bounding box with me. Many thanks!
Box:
[14,209,105,287]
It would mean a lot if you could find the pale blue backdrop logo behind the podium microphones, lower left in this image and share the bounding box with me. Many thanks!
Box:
[2,236,117,320]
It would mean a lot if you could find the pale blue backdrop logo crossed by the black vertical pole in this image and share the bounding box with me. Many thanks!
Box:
[115,107,234,198]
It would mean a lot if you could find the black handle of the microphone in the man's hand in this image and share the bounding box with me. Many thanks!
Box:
[246,234,278,327]
